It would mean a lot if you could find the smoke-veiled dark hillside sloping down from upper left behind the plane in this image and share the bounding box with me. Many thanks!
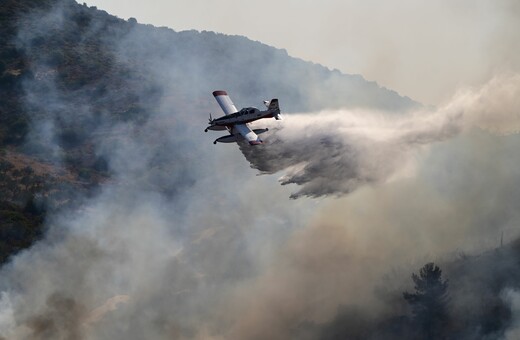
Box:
[0,0,418,262]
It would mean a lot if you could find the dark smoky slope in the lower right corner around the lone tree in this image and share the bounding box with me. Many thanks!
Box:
[314,240,520,339]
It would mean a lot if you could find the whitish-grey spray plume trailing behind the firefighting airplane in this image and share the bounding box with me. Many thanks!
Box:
[241,74,520,198]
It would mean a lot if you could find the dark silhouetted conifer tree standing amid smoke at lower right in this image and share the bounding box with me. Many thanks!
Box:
[403,263,449,339]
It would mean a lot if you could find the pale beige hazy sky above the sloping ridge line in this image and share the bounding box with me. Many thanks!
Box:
[80,0,520,104]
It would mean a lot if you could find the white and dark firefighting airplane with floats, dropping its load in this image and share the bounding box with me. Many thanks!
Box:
[204,90,282,145]
